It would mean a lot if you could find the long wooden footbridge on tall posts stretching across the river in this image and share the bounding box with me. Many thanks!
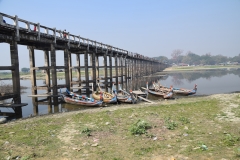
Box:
[0,13,167,115]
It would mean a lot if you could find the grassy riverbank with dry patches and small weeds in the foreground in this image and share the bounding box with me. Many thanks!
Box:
[0,93,240,160]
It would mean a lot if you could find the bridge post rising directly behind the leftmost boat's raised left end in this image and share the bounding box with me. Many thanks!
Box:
[64,47,71,90]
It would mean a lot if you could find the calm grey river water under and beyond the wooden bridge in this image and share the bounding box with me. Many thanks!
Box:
[0,69,240,118]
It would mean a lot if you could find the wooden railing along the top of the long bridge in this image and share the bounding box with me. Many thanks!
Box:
[0,12,157,62]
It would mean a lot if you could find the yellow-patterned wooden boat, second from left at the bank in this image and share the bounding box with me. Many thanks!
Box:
[92,84,117,103]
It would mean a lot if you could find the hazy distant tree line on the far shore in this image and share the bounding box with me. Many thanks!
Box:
[154,49,240,65]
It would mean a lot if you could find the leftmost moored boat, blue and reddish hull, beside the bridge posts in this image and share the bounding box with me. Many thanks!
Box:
[61,90,103,106]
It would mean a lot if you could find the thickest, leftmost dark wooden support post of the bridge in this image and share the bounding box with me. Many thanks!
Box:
[10,38,22,118]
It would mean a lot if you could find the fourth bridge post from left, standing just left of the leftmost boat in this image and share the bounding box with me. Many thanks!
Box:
[51,43,58,104]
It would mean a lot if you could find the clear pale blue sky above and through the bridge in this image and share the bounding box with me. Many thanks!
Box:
[0,0,240,68]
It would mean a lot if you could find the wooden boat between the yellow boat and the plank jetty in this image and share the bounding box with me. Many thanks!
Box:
[116,84,137,104]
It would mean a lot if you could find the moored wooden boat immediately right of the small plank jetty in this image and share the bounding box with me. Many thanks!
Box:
[141,83,173,99]
